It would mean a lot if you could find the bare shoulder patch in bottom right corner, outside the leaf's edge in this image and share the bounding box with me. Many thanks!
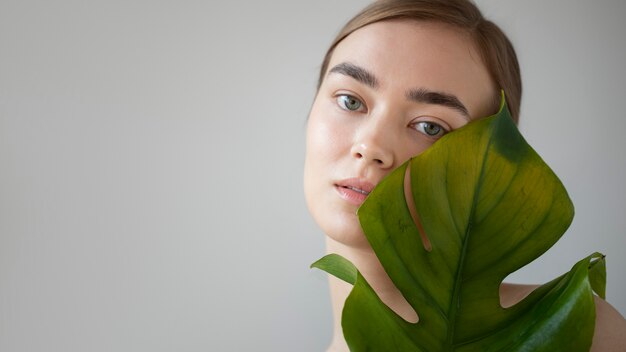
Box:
[591,297,626,352]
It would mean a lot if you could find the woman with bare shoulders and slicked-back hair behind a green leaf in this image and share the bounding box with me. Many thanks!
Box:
[304,0,626,351]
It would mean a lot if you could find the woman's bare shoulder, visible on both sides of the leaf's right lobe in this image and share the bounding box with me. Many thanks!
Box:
[500,283,626,352]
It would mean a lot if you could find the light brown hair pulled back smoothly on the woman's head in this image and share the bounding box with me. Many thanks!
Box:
[318,0,522,123]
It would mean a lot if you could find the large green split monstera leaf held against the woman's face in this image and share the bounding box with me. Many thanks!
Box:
[312,98,604,352]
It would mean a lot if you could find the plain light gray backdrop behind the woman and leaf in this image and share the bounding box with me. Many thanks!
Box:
[0,0,626,351]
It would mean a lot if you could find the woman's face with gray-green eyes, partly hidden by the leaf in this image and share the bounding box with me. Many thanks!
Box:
[304,21,499,247]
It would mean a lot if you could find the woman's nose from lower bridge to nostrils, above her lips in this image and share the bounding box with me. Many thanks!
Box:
[351,126,394,169]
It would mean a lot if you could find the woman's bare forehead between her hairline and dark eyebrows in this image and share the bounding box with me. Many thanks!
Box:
[329,20,497,117]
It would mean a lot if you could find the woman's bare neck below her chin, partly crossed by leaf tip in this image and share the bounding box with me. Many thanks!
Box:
[326,237,417,352]
